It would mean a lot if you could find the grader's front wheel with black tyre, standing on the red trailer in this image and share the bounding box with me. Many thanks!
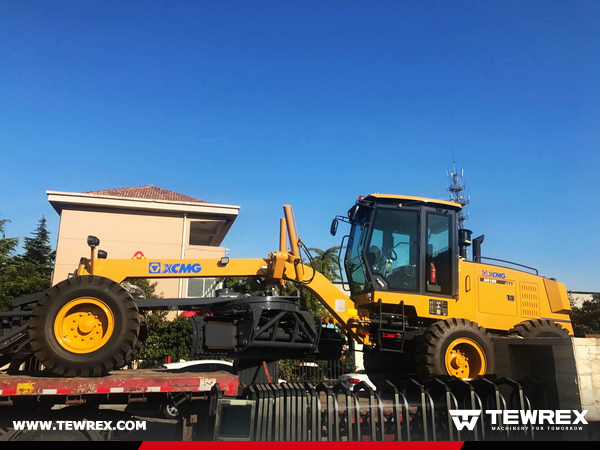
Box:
[29,275,140,377]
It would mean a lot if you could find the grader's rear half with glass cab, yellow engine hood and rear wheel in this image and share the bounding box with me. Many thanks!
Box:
[331,194,573,379]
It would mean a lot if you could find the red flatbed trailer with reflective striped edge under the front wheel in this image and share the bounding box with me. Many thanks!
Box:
[0,369,239,441]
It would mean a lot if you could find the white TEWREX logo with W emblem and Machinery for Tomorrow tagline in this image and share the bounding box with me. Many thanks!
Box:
[450,409,587,431]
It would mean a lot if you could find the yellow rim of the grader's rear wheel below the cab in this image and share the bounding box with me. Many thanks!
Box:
[445,338,487,380]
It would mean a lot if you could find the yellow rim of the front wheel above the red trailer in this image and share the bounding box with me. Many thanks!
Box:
[54,297,115,354]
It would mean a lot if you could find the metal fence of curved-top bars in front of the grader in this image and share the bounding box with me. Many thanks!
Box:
[237,378,584,441]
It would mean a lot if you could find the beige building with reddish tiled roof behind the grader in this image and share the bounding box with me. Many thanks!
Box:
[46,185,240,298]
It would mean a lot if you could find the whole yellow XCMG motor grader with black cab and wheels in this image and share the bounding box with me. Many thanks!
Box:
[22,194,573,379]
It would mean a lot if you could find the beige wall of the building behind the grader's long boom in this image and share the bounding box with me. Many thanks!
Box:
[53,208,225,297]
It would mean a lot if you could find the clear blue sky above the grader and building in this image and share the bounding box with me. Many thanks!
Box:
[0,0,600,291]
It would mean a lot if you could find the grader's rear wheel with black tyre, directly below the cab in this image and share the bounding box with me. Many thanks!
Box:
[416,319,494,380]
